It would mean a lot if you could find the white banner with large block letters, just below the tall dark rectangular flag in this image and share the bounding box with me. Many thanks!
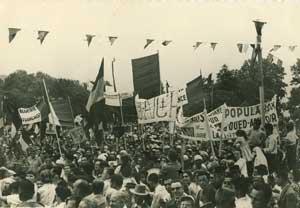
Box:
[135,91,178,124]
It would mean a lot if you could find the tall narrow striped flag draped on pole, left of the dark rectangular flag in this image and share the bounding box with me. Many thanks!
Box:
[86,58,105,112]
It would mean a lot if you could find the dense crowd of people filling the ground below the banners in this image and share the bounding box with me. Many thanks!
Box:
[0,120,300,208]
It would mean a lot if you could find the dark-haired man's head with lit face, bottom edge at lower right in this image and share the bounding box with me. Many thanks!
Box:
[250,184,272,208]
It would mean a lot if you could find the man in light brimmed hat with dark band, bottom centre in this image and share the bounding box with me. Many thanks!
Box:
[130,184,150,208]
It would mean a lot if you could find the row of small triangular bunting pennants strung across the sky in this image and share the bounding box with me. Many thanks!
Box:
[8,28,297,54]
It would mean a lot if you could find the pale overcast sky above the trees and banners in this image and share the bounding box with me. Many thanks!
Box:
[0,0,300,92]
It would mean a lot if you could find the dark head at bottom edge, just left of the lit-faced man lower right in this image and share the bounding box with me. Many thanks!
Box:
[216,188,235,208]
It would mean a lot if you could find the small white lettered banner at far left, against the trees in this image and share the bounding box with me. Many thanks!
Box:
[18,105,42,124]
